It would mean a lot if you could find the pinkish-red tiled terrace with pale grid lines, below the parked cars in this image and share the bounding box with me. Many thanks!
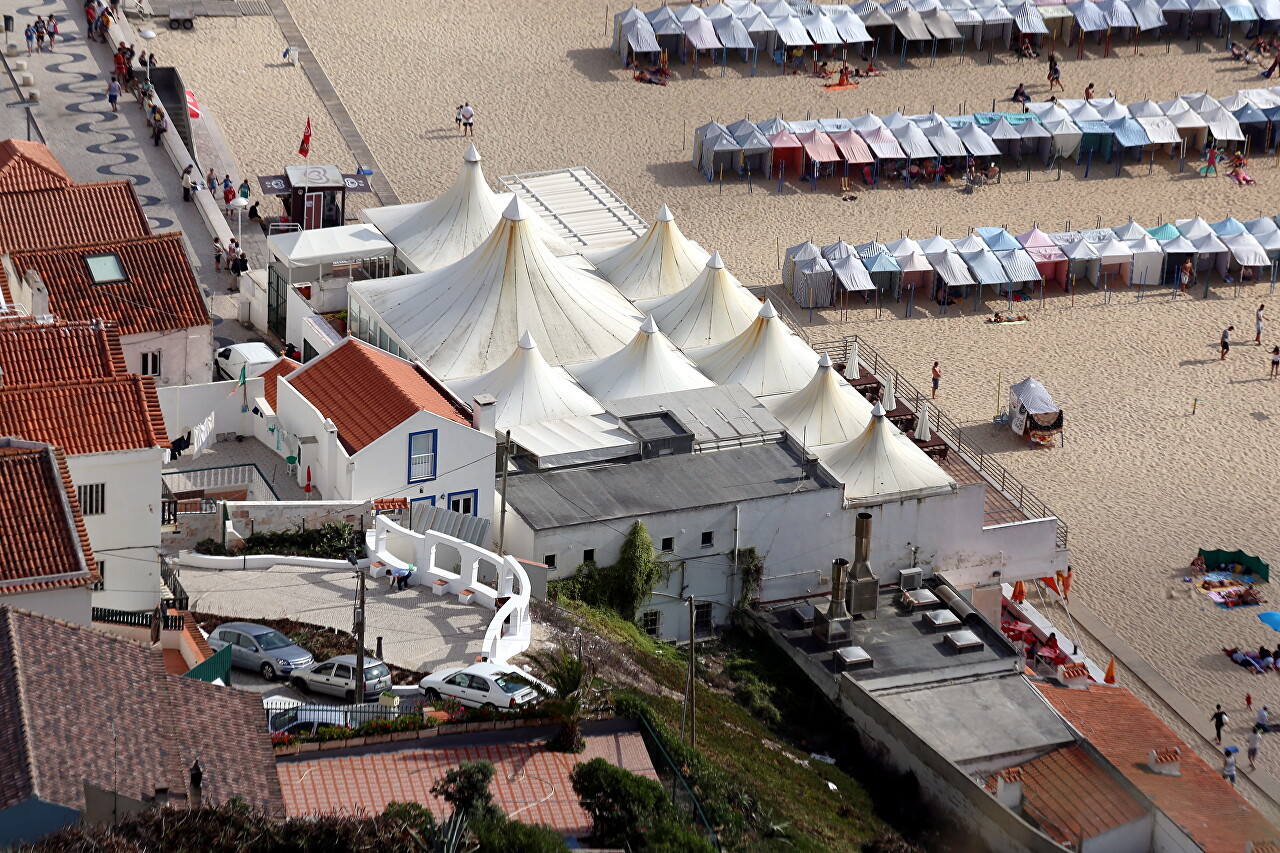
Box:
[279,731,657,838]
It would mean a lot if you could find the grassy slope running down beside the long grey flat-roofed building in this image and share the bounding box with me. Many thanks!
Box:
[550,603,911,853]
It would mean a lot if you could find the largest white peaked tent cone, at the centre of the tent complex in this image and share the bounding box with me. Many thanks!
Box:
[351,197,641,380]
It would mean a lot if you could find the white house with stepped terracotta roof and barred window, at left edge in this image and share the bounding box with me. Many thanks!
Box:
[0,318,170,610]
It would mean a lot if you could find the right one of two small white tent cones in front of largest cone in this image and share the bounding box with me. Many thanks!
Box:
[570,316,716,400]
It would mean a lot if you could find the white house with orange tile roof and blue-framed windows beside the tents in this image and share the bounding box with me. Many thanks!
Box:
[275,338,495,517]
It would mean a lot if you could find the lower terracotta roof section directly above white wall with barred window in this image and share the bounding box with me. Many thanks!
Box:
[0,375,169,456]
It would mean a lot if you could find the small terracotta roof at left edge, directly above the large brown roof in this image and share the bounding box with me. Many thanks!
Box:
[0,437,97,596]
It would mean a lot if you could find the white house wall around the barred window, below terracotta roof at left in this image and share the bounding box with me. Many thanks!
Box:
[67,447,164,610]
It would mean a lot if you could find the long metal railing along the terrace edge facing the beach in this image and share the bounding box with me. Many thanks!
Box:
[809,334,1068,549]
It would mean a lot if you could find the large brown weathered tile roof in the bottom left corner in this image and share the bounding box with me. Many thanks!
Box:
[0,607,283,815]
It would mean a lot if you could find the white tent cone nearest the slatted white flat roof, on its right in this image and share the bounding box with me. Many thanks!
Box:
[588,205,710,301]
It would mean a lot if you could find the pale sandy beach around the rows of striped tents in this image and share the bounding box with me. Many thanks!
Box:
[156,0,1280,788]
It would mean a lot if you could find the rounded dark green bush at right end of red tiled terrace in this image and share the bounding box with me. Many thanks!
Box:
[570,758,672,849]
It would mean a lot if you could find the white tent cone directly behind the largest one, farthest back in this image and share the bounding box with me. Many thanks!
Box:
[361,145,571,273]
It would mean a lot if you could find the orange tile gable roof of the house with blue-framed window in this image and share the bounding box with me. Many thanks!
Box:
[287,338,471,453]
